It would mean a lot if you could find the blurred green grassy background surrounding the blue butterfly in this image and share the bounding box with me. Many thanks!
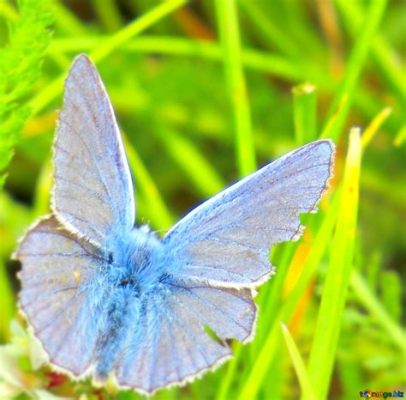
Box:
[0,0,406,400]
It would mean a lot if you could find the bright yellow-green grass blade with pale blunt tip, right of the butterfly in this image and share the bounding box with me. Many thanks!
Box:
[309,129,362,399]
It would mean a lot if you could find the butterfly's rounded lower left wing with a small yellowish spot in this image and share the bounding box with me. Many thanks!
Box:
[14,216,106,375]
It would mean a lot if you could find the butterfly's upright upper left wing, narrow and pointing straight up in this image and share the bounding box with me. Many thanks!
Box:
[53,55,135,244]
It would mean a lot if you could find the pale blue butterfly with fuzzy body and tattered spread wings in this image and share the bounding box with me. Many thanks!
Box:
[14,55,334,394]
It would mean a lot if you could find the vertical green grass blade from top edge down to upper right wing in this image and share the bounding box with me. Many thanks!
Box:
[216,0,256,176]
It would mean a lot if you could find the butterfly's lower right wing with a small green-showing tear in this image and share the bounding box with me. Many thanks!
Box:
[112,280,256,394]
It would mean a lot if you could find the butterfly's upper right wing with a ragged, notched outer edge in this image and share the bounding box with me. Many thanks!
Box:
[164,140,334,287]
